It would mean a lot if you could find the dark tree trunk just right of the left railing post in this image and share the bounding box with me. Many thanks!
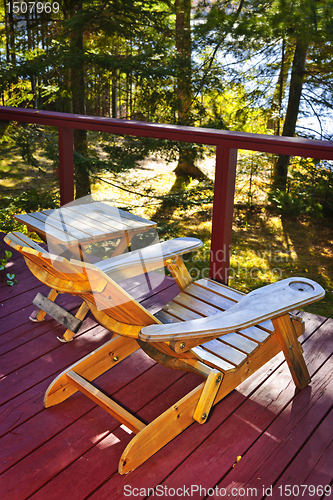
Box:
[70,2,91,199]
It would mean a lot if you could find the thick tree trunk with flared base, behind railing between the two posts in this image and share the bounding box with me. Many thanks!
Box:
[175,0,205,179]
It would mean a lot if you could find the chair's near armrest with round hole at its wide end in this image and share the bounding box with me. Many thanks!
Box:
[139,278,325,342]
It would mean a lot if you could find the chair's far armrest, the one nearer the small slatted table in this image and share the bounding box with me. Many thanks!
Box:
[95,238,202,281]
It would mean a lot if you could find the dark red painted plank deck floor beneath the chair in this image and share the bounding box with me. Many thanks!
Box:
[0,235,333,500]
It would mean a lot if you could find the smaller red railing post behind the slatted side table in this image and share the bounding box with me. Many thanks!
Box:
[58,127,74,206]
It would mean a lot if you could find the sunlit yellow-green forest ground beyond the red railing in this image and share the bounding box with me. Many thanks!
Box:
[0,148,333,317]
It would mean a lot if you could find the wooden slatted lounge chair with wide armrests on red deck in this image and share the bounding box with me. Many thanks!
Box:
[3,230,325,474]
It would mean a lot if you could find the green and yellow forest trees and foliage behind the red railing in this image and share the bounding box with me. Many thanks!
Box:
[0,0,333,200]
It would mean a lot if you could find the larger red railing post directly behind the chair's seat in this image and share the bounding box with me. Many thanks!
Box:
[209,143,237,285]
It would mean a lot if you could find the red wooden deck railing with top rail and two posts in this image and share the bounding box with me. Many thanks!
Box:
[0,106,333,283]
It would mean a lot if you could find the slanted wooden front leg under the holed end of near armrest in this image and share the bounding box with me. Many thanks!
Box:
[273,314,311,389]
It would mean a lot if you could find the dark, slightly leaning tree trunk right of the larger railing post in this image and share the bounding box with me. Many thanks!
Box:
[273,40,309,191]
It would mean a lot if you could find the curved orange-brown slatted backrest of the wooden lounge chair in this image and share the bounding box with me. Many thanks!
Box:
[4,232,159,337]
